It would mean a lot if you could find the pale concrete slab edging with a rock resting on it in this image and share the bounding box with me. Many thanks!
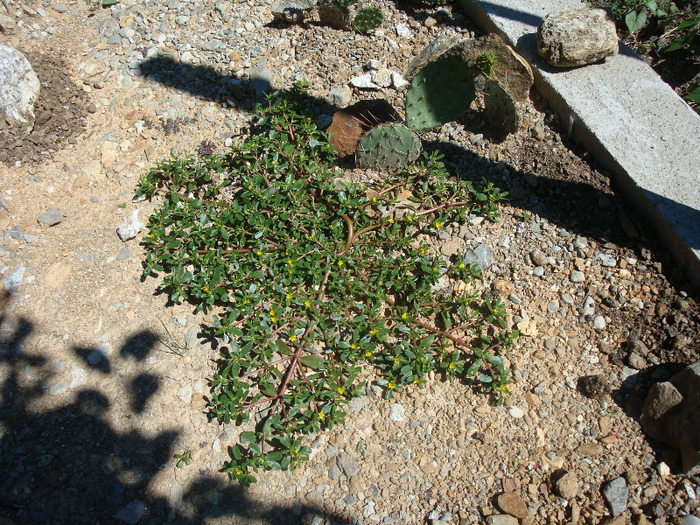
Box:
[460,0,700,284]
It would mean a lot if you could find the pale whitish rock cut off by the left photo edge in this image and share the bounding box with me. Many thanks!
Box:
[0,46,41,132]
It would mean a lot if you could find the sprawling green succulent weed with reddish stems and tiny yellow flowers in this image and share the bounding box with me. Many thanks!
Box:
[137,85,517,485]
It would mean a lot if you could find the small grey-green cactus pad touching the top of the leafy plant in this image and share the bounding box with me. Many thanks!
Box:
[355,124,421,171]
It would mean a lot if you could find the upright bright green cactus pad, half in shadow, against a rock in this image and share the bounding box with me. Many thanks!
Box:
[406,56,475,131]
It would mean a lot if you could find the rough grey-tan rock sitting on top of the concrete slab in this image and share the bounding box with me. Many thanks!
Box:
[537,7,618,67]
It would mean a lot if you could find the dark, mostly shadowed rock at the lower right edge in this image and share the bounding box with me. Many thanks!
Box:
[640,361,700,476]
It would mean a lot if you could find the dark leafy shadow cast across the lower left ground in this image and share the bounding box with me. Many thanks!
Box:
[0,296,351,525]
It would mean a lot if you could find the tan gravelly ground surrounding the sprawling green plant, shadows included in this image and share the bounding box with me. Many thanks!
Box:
[0,0,700,525]
